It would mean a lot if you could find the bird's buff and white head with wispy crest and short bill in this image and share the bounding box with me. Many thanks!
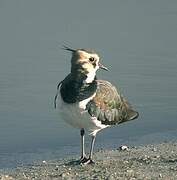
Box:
[64,46,108,83]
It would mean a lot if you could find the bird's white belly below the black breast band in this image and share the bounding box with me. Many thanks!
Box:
[56,93,108,135]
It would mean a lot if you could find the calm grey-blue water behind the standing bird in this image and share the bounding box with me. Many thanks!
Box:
[0,0,177,168]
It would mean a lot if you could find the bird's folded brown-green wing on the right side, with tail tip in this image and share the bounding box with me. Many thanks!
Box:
[87,80,138,125]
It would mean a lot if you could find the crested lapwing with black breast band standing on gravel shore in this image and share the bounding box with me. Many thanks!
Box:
[54,46,139,164]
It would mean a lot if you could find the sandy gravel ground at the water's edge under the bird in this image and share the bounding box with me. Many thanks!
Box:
[0,141,177,180]
